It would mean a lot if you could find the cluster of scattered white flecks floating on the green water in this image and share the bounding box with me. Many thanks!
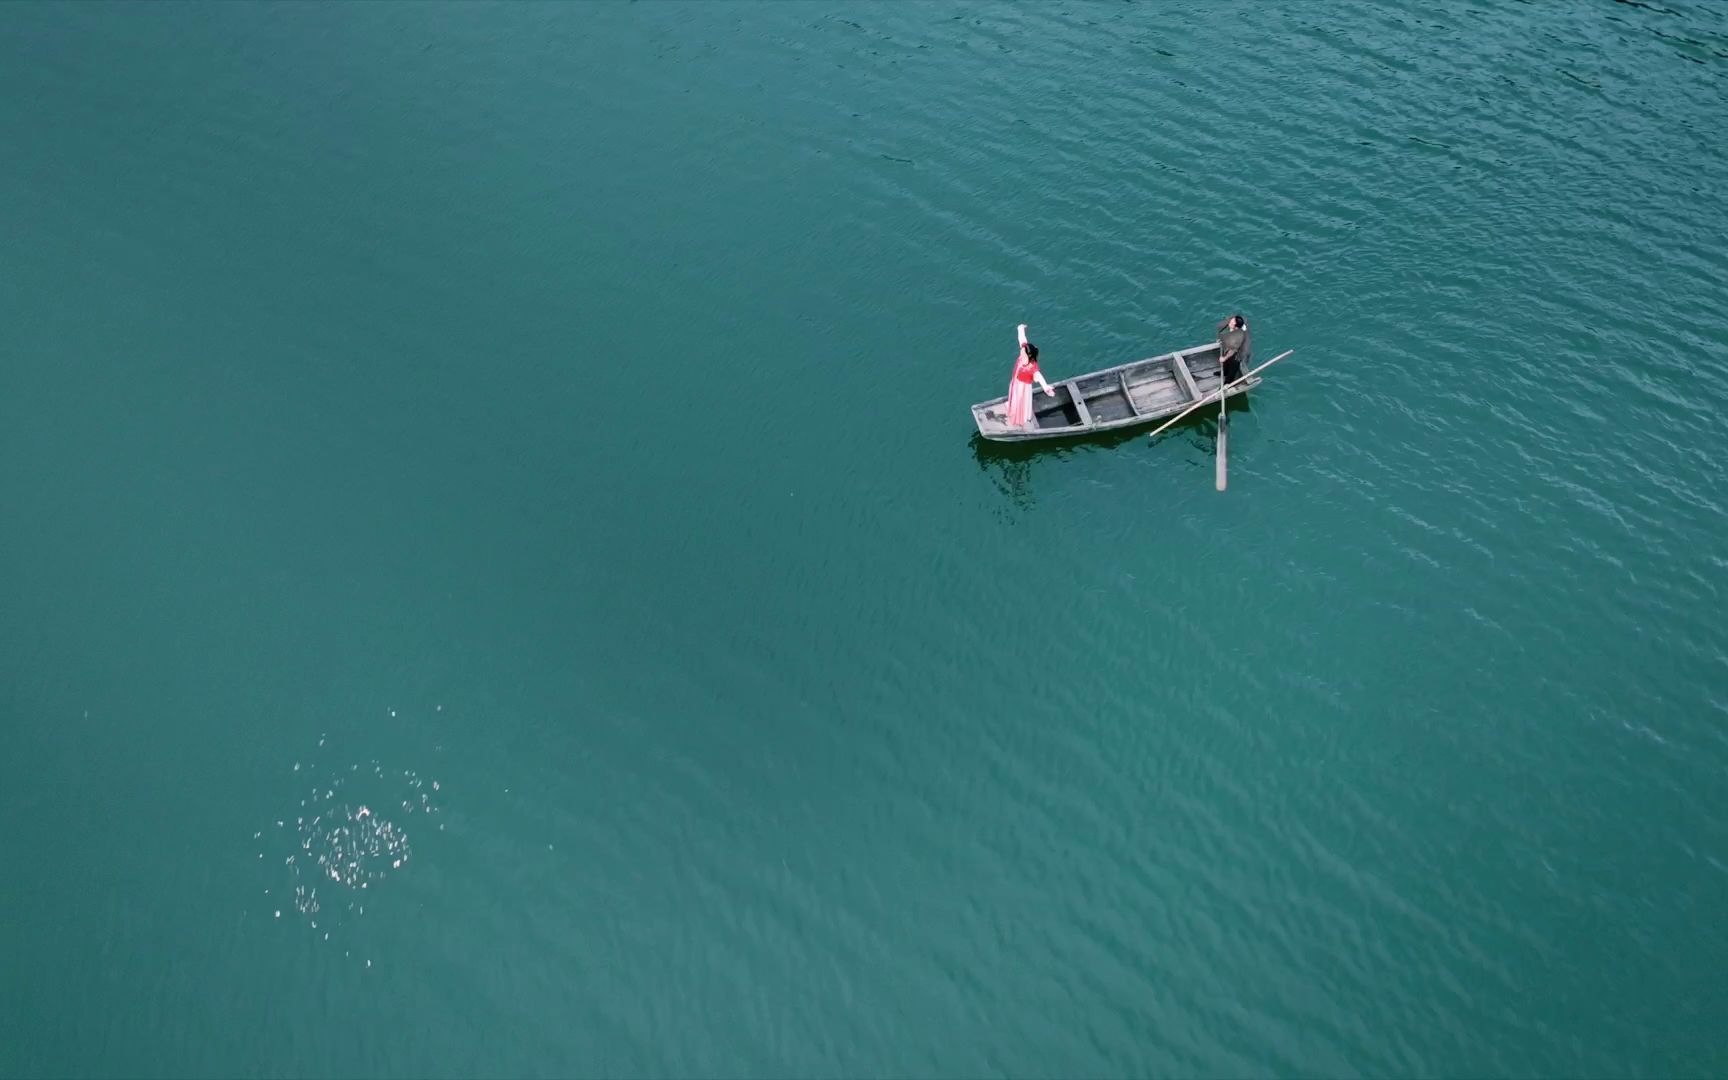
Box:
[252,736,444,968]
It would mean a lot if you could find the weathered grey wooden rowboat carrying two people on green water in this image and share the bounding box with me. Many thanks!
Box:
[973,342,1261,442]
